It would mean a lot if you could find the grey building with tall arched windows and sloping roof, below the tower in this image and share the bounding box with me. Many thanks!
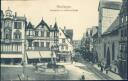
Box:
[101,17,120,73]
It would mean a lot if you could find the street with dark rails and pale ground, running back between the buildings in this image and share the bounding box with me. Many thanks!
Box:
[58,55,113,80]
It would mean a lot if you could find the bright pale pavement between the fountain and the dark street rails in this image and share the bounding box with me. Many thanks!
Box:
[58,62,101,80]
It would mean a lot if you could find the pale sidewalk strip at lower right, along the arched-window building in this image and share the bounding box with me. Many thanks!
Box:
[93,64,123,80]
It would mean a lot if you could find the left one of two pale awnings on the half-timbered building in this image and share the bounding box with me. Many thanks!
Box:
[27,51,41,59]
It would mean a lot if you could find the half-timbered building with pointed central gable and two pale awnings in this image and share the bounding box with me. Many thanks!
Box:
[26,19,58,63]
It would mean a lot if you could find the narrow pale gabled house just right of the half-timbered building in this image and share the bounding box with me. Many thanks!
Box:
[58,27,73,62]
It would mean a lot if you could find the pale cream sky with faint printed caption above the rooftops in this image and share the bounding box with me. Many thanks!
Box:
[1,0,120,40]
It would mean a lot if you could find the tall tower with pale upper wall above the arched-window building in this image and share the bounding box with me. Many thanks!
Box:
[97,0,121,62]
